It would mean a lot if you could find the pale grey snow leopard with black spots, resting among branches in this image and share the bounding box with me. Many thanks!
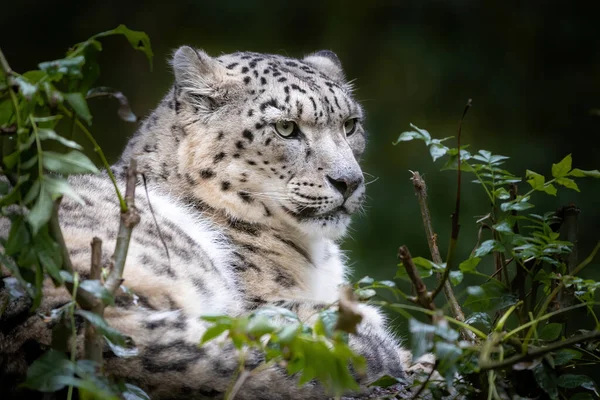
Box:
[0,46,420,400]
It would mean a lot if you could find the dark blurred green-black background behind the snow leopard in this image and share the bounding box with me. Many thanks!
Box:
[0,0,600,330]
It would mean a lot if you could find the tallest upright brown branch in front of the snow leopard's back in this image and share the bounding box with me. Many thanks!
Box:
[104,159,140,293]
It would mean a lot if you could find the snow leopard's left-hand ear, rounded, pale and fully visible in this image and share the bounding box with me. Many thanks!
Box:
[171,46,236,99]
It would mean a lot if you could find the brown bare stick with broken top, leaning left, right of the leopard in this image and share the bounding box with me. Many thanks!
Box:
[412,171,477,341]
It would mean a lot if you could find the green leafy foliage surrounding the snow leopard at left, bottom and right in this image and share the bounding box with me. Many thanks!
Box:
[0,26,600,399]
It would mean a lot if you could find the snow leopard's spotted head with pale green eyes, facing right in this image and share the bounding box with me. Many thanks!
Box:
[172,47,366,238]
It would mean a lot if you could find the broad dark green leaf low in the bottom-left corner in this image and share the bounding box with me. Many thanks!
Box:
[24,350,74,392]
